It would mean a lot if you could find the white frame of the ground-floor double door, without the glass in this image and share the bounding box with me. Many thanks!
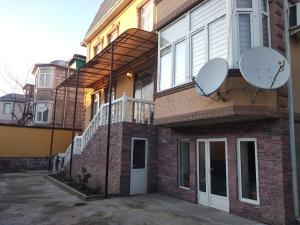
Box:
[196,138,230,212]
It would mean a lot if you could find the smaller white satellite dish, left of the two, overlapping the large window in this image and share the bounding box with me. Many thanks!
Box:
[194,58,228,96]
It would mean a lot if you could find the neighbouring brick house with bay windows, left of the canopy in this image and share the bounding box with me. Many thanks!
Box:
[32,55,85,128]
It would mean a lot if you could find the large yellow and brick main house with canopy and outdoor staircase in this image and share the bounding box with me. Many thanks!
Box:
[55,0,300,225]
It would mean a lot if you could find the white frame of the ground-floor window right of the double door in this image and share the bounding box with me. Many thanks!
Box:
[236,138,260,205]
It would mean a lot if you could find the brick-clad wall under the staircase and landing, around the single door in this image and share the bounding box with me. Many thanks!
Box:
[68,123,157,195]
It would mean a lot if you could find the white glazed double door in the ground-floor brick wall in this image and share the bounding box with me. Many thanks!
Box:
[197,139,229,211]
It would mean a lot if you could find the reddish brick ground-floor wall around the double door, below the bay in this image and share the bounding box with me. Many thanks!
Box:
[157,119,294,225]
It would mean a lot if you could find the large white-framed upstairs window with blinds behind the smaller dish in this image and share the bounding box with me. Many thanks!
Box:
[158,0,228,91]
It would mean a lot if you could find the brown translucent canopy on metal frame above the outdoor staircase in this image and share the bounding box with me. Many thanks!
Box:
[57,28,158,88]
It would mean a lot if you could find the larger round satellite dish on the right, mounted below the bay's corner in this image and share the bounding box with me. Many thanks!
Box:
[239,47,290,90]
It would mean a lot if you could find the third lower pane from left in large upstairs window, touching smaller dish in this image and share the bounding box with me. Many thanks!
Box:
[191,30,206,77]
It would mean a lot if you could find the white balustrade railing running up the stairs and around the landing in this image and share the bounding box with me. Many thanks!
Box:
[60,93,154,163]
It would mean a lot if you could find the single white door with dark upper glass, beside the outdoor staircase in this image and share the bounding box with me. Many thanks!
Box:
[130,138,147,195]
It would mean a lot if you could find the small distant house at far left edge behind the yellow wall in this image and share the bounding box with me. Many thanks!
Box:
[0,93,25,124]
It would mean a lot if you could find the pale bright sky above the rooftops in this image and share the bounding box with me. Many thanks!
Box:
[0,0,102,96]
